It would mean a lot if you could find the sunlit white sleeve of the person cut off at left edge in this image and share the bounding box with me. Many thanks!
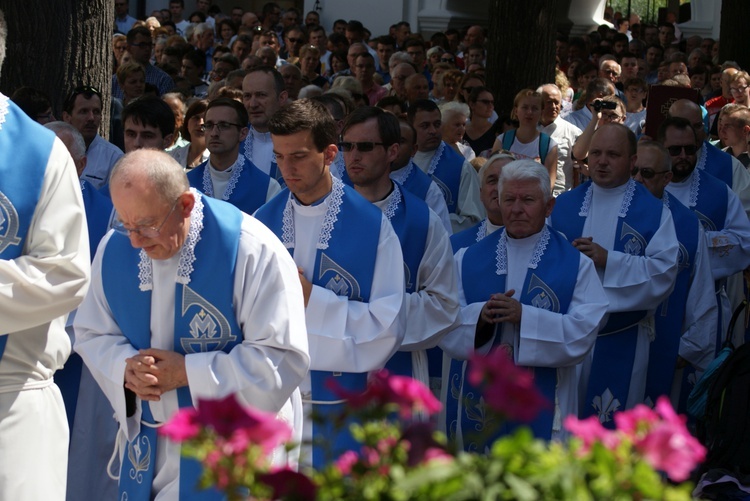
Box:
[0,138,91,334]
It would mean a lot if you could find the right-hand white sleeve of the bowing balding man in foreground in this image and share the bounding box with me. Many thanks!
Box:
[185,216,310,412]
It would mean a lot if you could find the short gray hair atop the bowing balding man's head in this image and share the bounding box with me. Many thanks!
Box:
[109,149,190,204]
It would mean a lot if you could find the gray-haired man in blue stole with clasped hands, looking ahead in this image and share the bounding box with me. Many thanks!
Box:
[441,160,609,450]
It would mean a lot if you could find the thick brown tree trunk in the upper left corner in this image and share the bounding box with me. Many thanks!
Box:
[0,0,115,138]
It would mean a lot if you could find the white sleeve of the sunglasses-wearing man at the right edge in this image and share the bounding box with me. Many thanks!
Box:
[706,187,750,280]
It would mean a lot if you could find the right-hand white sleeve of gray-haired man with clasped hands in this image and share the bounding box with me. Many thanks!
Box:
[516,254,609,367]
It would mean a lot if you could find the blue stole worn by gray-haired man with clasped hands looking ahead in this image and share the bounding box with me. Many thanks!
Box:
[460,226,581,451]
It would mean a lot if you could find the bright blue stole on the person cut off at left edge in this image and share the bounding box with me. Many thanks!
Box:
[0,98,55,361]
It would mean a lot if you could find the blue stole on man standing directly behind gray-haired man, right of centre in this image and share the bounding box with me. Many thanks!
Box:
[550,179,664,427]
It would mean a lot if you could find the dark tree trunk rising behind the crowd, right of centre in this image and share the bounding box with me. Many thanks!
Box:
[487,0,559,116]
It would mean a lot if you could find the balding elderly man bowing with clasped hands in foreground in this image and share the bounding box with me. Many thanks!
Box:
[74,150,309,501]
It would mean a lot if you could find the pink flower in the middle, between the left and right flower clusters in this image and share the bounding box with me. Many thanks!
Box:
[326,369,442,418]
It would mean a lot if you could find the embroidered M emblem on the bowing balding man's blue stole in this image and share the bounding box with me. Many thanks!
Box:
[180,285,237,353]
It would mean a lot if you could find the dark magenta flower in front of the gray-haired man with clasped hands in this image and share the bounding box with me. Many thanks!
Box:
[468,350,549,422]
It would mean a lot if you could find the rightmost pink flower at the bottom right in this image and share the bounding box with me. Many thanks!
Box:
[635,397,706,482]
